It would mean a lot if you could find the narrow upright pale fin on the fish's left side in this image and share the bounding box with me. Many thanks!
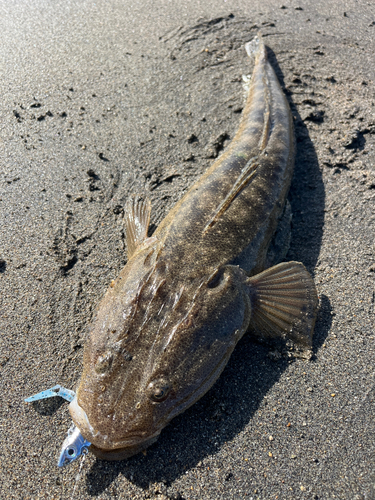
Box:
[125,196,151,259]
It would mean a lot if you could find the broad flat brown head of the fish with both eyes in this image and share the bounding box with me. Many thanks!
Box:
[70,258,250,460]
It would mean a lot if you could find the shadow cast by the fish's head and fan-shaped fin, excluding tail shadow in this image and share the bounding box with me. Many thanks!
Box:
[86,295,332,494]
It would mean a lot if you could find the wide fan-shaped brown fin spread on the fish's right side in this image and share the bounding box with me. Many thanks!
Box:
[247,262,318,349]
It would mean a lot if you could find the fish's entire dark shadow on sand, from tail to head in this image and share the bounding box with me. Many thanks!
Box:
[86,42,332,492]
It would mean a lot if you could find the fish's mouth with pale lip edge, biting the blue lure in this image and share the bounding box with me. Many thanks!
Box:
[69,397,161,454]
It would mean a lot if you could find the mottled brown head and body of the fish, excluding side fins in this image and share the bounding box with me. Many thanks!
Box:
[71,36,318,460]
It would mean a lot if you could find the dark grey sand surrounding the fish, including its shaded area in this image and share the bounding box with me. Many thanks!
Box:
[0,0,375,500]
